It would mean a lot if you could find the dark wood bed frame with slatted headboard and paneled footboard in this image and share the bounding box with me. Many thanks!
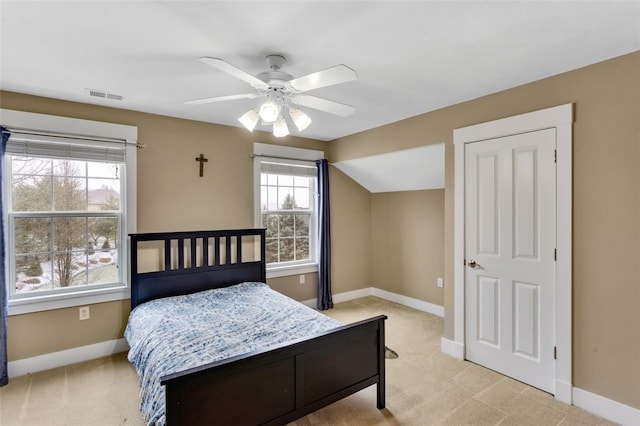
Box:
[130,229,386,425]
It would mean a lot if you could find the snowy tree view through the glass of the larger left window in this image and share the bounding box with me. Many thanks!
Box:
[10,156,122,295]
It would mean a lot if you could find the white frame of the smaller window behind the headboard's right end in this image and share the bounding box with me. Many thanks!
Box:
[253,142,324,278]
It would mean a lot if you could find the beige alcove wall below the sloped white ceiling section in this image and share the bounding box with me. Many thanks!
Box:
[371,189,444,305]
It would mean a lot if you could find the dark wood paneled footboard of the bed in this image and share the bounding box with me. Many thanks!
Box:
[161,315,387,425]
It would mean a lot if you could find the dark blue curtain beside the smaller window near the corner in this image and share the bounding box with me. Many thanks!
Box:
[316,160,333,311]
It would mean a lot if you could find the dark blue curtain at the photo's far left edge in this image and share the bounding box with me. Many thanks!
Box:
[0,127,10,386]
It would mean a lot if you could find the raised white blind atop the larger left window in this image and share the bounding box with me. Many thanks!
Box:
[6,131,126,163]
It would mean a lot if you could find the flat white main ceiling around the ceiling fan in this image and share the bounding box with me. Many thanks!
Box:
[0,0,640,140]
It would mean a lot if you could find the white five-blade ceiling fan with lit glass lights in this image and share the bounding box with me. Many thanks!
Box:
[185,54,358,137]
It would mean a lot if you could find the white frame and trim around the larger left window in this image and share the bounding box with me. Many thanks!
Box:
[0,109,138,315]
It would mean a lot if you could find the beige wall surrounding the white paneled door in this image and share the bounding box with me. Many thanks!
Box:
[330,52,640,408]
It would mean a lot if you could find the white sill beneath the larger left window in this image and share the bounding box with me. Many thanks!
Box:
[8,286,131,316]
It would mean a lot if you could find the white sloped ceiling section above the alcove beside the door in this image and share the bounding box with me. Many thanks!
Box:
[333,143,444,193]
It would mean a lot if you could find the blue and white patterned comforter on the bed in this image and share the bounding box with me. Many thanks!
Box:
[124,283,342,425]
